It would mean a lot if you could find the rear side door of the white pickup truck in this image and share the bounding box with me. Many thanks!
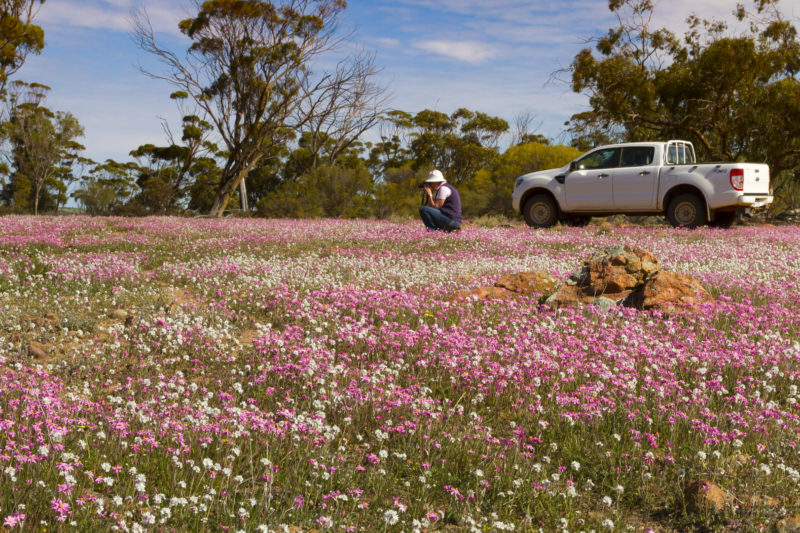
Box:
[613,146,659,211]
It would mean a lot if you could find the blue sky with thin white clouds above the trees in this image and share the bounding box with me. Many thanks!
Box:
[15,0,756,161]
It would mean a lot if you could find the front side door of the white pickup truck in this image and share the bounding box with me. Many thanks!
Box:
[564,148,620,211]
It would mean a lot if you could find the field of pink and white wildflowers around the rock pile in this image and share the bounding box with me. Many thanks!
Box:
[0,217,800,532]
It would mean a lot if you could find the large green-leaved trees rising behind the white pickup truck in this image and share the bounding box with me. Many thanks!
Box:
[571,0,800,203]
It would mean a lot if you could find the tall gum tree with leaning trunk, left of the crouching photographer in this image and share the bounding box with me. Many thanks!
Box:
[134,0,370,216]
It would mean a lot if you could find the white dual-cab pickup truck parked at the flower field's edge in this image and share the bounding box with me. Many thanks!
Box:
[512,141,772,228]
